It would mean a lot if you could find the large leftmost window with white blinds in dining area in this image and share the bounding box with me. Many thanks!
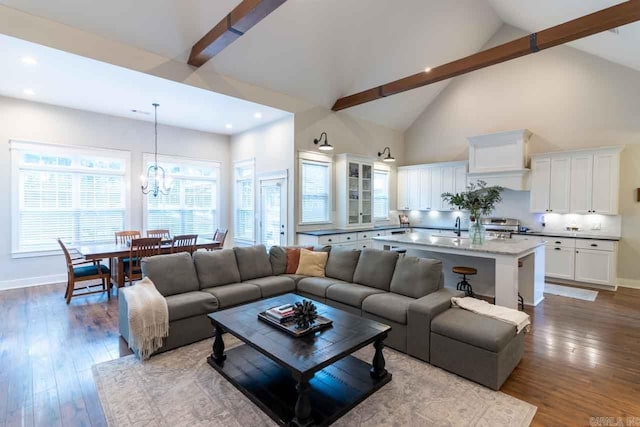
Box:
[11,141,129,253]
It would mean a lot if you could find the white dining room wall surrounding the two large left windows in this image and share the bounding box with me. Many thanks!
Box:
[0,97,230,289]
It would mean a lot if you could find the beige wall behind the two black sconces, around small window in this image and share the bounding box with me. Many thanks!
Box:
[295,107,404,234]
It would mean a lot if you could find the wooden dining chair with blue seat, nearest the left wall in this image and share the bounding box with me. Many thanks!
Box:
[58,239,111,304]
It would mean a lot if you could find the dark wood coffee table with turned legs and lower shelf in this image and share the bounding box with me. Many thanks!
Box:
[207,294,391,426]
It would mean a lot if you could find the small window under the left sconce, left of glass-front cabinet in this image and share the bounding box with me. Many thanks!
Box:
[300,160,331,224]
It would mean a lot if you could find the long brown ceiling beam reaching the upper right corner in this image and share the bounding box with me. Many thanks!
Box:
[332,0,640,111]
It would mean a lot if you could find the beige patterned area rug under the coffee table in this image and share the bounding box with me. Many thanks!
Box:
[93,334,537,427]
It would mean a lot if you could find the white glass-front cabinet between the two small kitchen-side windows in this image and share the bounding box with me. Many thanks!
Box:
[336,154,373,227]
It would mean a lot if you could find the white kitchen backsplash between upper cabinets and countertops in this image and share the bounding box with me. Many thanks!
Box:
[395,190,621,236]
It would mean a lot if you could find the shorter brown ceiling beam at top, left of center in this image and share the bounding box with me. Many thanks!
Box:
[188,0,287,67]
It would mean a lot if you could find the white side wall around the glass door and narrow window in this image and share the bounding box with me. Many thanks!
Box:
[229,115,295,243]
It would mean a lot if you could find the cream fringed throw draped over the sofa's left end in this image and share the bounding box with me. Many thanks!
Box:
[120,277,169,360]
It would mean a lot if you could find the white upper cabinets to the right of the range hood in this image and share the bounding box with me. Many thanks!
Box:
[531,147,621,215]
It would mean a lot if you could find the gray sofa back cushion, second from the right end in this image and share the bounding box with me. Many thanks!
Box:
[353,249,398,291]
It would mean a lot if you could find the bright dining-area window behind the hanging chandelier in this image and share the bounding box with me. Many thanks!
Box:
[144,154,219,237]
